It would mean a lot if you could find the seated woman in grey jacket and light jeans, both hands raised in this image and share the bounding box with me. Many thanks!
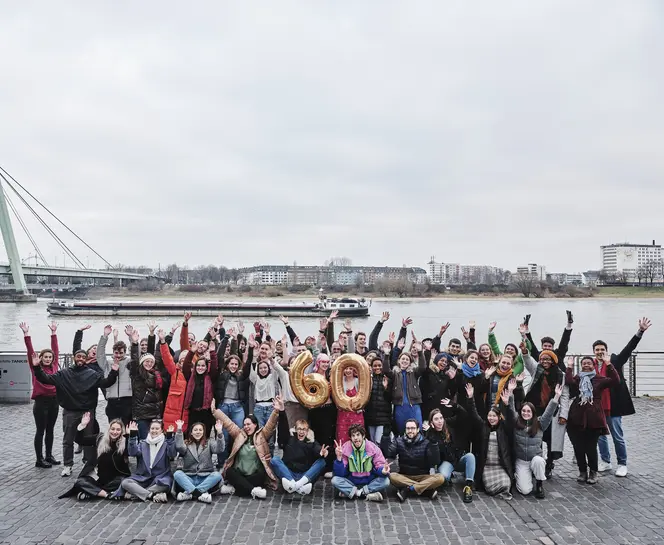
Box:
[173,420,224,503]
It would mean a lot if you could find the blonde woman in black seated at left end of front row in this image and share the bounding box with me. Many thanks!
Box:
[60,413,131,500]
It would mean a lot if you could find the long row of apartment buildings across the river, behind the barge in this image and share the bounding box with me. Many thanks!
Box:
[237,265,427,286]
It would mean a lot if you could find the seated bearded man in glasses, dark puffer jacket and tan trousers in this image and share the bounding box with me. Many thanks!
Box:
[381,418,445,502]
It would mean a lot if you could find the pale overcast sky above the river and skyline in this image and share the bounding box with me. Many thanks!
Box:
[0,0,664,272]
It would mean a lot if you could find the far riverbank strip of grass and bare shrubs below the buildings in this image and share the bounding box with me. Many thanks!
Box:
[49,286,664,301]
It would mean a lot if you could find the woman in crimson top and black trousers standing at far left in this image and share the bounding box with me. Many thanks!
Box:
[19,322,60,469]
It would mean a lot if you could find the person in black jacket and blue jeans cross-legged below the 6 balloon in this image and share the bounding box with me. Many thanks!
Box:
[271,420,328,495]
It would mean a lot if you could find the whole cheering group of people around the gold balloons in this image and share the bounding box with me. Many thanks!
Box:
[20,311,651,503]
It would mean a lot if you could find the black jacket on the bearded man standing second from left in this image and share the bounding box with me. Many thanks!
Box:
[33,364,118,412]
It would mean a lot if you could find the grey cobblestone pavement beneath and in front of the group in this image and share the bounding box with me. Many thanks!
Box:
[0,399,664,545]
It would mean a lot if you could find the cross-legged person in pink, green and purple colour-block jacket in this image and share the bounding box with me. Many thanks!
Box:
[332,424,390,502]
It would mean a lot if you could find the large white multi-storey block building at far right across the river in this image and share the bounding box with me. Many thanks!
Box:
[600,240,662,282]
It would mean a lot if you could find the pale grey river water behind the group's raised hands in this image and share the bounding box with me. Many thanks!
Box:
[0,298,664,353]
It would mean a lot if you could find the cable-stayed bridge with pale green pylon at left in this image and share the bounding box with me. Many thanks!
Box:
[0,167,151,301]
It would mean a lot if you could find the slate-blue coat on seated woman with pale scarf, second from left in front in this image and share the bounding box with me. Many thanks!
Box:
[113,432,177,497]
